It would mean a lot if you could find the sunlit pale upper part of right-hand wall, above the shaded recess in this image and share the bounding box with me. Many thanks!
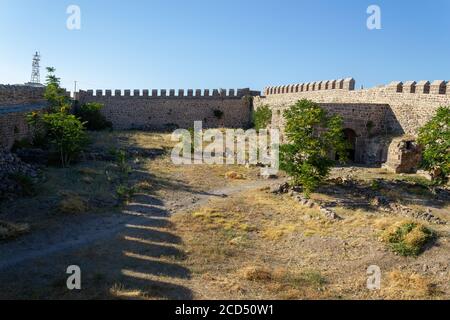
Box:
[255,78,450,136]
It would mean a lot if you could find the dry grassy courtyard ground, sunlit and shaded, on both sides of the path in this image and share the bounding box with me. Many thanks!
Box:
[0,132,450,299]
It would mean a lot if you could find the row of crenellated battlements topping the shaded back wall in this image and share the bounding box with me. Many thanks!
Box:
[76,88,261,100]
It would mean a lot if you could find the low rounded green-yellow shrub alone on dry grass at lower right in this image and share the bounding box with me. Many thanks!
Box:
[381,222,436,257]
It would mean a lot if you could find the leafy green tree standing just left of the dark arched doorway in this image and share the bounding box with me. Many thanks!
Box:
[280,100,348,195]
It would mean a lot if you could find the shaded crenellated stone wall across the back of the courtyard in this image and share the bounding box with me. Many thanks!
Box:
[77,89,260,130]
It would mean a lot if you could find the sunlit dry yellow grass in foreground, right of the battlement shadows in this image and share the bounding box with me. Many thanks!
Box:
[173,190,450,299]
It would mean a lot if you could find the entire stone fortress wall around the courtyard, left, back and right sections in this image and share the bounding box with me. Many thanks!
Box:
[0,78,450,170]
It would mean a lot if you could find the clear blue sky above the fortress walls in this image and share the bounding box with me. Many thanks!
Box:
[0,0,450,90]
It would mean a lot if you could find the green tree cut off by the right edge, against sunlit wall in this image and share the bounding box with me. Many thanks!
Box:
[418,107,450,185]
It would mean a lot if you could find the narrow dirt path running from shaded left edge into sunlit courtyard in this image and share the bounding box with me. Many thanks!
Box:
[0,180,274,271]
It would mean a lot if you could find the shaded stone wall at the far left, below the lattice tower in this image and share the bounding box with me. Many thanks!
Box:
[0,85,46,149]
